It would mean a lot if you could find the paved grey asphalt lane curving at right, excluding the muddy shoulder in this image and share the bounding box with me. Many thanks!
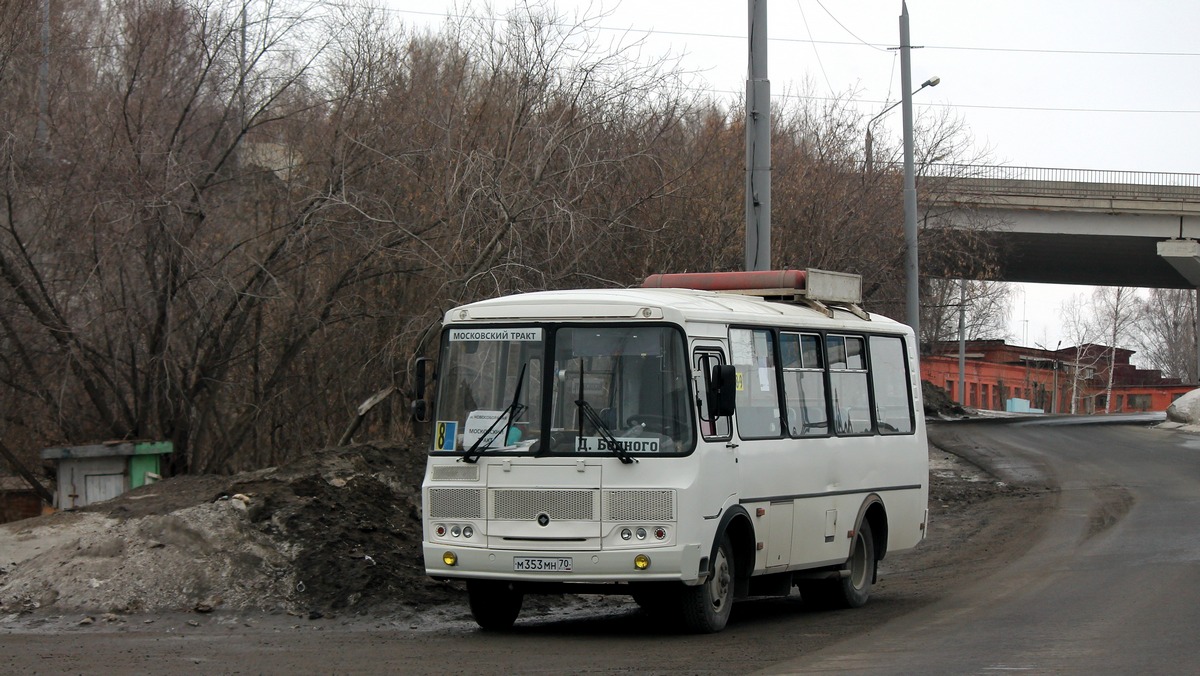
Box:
[763,423,1200,674]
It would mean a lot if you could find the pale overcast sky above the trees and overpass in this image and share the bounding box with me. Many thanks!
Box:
[386,0,1200,347]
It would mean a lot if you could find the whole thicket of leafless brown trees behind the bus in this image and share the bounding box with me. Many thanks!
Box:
[0,0,1003,471]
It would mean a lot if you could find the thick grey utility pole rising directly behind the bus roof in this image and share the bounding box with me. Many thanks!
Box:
[746,0,770,270]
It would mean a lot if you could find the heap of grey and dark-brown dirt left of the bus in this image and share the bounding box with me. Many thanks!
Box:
[0,445,460,615]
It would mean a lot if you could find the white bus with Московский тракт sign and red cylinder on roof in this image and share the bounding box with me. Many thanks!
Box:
[418,270,929,632]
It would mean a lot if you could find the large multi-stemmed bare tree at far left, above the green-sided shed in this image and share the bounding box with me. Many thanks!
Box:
[0,0,350,468]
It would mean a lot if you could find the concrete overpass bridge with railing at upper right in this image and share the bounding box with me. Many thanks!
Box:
[917,164,1200,288]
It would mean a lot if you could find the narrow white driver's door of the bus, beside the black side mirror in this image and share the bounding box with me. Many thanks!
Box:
[691,340,739,518]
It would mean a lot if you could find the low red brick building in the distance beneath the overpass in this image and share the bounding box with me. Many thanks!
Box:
[920,340,1196,413]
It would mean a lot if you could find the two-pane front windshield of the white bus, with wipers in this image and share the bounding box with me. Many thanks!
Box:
[433,324,696,462]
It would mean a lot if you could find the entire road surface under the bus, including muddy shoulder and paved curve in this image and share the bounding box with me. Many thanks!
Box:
[0,423,1200,675]
